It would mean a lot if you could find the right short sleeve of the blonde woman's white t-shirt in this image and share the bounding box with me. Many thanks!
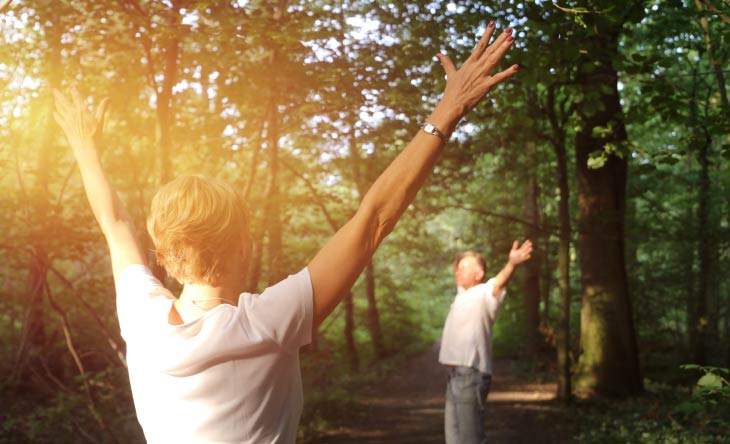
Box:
[239,268,313,349]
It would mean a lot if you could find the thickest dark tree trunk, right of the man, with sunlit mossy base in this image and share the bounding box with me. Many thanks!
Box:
[575,42,642,396]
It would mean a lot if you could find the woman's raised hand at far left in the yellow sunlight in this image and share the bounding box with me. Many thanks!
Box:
[53,88,109,150]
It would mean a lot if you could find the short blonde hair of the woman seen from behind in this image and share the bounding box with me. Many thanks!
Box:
[147,175,250,285]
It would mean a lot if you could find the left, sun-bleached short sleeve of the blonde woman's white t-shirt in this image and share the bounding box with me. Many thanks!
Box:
[115,264,174,342]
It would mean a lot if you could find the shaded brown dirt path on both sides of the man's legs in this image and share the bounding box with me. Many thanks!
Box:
[307,344,575,444]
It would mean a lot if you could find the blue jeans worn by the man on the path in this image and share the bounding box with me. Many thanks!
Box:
[444,367,492,444]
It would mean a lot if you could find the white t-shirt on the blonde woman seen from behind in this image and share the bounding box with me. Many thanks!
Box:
[117,265,313,444]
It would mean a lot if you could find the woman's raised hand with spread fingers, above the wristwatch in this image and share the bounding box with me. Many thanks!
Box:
[436,22,519,118]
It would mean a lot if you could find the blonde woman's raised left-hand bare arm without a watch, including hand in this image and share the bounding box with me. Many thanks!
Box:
[53,88,146,279]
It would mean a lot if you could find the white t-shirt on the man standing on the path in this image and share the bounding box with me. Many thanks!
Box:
[439,278,506,375]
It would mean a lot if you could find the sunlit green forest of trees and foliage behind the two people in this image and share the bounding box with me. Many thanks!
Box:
[0,0,730,443]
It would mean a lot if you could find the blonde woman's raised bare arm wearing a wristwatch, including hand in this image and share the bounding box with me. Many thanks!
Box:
[308,23,517,327]
